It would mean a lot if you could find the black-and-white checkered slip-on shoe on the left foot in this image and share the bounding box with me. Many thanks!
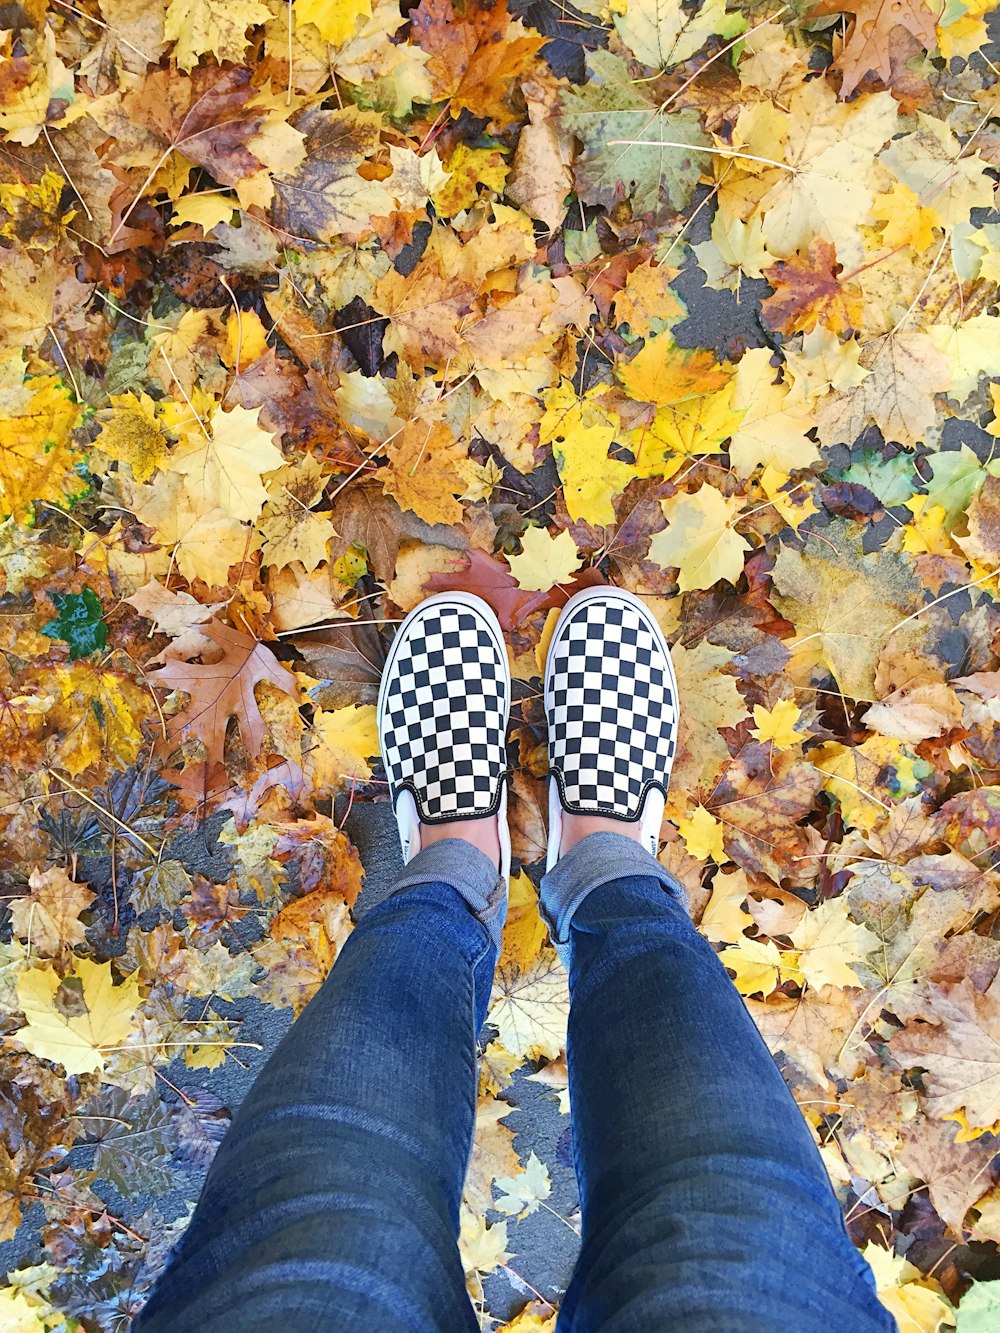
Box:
[377,592,511,878]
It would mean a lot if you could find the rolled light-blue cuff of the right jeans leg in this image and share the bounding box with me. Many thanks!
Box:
[539,833,688,945]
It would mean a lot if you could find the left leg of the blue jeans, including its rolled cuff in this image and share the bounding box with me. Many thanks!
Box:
[133,842,497,1333]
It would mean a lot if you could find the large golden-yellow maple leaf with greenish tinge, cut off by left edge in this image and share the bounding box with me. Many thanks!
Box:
[0,375,88,520]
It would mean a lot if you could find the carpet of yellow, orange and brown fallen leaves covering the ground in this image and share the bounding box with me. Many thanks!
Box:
[0,0,1000,1333]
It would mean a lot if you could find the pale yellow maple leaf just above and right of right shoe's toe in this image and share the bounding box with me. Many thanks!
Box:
[649,485,751,592]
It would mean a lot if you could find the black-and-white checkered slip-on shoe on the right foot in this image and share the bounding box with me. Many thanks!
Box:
[545,588,679,870]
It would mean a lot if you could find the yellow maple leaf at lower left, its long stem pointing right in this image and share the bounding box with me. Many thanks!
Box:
[16,958,139,1074]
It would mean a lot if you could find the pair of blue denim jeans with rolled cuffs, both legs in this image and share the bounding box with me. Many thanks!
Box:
[133,833,895,1333]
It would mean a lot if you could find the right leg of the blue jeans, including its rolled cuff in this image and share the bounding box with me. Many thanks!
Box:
[541,833,895,1333]
